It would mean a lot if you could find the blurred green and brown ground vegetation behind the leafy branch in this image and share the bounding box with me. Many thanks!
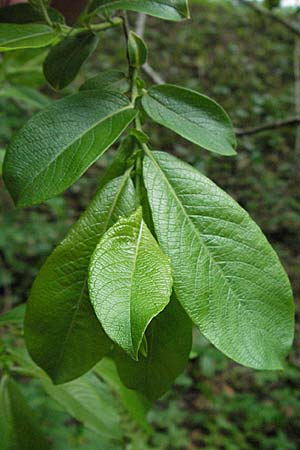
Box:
[0,0,300,450]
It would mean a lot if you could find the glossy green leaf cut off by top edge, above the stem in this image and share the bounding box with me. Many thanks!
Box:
[90,0,189,20]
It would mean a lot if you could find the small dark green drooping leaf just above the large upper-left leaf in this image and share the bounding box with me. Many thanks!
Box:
[43,31,99,90]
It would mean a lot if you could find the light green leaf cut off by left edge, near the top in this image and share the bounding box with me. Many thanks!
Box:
[0,23,57,52]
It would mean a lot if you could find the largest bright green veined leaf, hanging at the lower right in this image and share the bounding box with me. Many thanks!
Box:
[144,152,294,369]
